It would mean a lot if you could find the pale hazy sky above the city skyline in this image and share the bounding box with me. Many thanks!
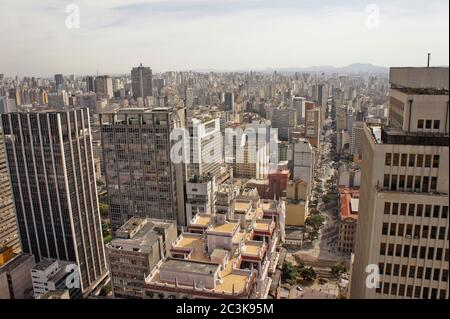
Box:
[0,0,449,76]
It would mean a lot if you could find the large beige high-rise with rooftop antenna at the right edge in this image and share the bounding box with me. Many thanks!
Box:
[350,67,449,299]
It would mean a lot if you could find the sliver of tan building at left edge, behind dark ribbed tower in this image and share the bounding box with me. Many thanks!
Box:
[0,127,20,253]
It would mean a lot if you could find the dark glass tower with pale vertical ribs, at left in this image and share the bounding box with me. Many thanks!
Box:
[1,108,106,291]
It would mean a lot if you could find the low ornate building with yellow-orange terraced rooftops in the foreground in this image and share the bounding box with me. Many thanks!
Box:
[145,193,284,299]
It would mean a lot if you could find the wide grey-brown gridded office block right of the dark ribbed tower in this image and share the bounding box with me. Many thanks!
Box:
[100,107,186,231]
